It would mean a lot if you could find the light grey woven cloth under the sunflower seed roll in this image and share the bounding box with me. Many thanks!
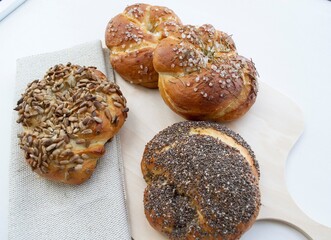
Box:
[8,41,130,240]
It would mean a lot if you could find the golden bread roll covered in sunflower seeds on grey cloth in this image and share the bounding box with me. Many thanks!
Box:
[15,63,128,184]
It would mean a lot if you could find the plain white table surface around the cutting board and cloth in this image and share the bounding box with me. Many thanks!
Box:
[0,0,331,240]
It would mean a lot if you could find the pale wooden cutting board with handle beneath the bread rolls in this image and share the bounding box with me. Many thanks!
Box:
[116,75,331,240]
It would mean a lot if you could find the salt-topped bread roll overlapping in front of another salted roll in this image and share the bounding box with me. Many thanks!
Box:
[153,25,257,122]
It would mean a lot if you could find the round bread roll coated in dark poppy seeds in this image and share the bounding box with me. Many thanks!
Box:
[141,121,260,240]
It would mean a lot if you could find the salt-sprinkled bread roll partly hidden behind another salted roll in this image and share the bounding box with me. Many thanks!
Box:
[106,4,181,88]
